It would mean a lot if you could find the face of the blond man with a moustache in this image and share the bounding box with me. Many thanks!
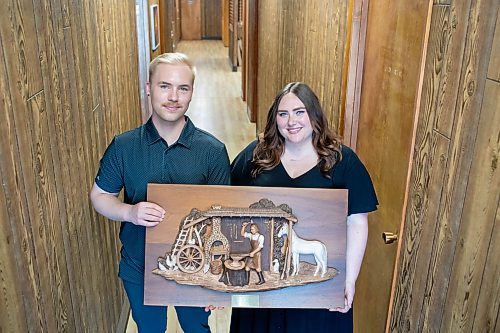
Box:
[147,64,193,123]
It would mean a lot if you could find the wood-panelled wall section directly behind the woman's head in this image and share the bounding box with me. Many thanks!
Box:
[257,0,348,133]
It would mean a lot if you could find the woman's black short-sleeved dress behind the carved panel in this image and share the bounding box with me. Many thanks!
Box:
[231,141,378,333]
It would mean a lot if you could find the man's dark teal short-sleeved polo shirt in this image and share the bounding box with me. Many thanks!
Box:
[95,117,231,282]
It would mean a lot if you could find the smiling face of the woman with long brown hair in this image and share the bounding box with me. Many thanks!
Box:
[276,93,313,144]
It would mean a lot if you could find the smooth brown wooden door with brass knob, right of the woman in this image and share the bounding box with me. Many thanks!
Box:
[354,0,429,332]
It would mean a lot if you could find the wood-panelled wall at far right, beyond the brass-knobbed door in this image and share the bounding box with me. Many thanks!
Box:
[388,0,500,332]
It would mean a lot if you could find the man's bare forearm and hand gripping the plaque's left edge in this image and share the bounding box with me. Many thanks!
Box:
[90,183,165,227]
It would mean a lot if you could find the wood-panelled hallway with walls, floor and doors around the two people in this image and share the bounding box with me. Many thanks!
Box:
[0,0,500,333]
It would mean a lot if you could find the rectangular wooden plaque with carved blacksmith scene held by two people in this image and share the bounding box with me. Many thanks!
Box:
[144,184,347,308]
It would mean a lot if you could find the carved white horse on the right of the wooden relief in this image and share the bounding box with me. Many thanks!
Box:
[278,223,328,277]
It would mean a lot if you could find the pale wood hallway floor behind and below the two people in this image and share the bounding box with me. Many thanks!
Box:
[126,40,252,333]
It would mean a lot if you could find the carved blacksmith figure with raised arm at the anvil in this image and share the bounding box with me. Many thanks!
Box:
[241,221,266,285]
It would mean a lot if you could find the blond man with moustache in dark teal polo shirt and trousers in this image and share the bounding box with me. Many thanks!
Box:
[90,53,230,333]
